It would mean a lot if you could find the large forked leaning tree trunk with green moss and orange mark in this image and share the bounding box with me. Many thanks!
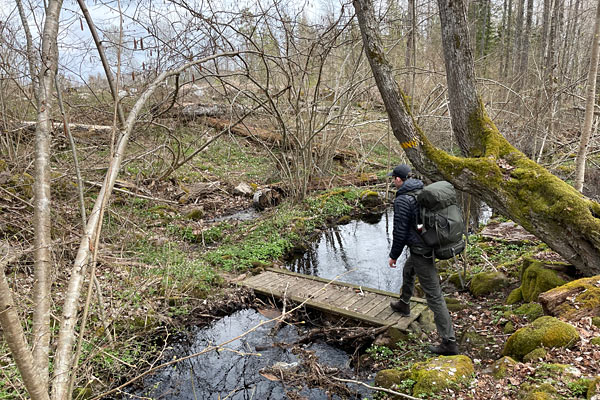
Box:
[354,0,600,275]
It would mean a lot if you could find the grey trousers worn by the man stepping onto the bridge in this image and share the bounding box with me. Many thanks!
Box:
[400,251,456,340]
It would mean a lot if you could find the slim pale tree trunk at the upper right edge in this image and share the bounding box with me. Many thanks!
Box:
[575,2,600,192]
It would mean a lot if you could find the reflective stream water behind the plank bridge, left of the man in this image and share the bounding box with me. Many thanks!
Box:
[286,209,407,293]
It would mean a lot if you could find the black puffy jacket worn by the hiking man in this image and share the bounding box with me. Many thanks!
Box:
[390,178,424,260]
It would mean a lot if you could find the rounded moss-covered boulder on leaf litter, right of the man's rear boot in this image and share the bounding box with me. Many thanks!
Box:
[502,316,580,360]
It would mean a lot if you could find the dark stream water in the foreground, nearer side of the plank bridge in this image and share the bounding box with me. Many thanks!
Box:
[132,310,367,400]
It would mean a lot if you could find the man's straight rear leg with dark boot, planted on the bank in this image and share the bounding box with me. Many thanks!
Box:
[414,255,458,354]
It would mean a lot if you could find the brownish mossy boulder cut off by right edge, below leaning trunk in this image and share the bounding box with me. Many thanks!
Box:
[539,275,600,321]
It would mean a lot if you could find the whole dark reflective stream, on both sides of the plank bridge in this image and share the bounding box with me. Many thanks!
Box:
[126,205,488,400]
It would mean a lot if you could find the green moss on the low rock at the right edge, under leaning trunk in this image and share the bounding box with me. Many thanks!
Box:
[550,275,600,322]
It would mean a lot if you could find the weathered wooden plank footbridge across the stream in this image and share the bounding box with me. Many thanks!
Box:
[240,268,427,330]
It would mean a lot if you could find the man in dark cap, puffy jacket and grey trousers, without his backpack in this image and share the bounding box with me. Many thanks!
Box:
[388,164,458,355]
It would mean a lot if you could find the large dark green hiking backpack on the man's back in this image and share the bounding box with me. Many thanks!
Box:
[415,181,466,260]
